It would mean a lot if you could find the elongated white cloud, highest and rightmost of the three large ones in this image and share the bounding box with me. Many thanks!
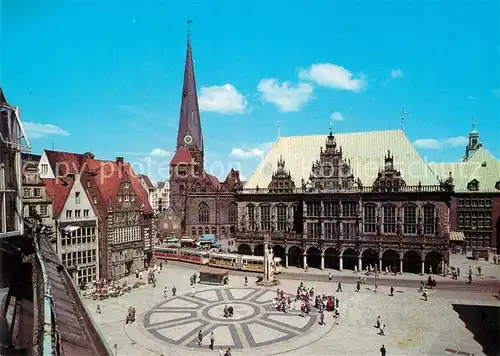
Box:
[299,63,366,92]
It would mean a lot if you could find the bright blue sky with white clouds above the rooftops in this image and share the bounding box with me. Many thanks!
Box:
[0,0,500,180]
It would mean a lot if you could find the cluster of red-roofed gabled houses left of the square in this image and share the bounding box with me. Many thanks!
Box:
[39,150,153,283]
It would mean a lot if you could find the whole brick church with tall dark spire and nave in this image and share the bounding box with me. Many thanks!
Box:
[166,34,241,237]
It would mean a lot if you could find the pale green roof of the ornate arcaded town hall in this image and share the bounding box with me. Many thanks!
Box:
[245,130,438,188]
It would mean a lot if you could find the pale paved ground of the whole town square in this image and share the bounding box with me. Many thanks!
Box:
[87,265,500,356]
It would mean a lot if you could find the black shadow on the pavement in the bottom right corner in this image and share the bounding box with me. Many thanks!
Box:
[453,304,500,356]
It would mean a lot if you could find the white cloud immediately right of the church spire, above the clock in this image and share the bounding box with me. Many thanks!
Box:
[198,84,248,114]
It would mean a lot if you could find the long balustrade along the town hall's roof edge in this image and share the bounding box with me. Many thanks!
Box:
[237,184,453,195]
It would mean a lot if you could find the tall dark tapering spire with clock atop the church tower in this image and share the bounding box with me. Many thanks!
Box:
[177,20,203,152]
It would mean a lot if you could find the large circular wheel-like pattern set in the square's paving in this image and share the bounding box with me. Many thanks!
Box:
[144,288,318,349]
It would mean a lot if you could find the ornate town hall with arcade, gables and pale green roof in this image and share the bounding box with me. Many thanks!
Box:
[235,131,453,273]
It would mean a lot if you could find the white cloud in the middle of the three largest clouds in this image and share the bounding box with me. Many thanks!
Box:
[257,79,314,112]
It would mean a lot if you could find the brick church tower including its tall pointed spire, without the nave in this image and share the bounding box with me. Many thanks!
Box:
[170,28,204,233]
